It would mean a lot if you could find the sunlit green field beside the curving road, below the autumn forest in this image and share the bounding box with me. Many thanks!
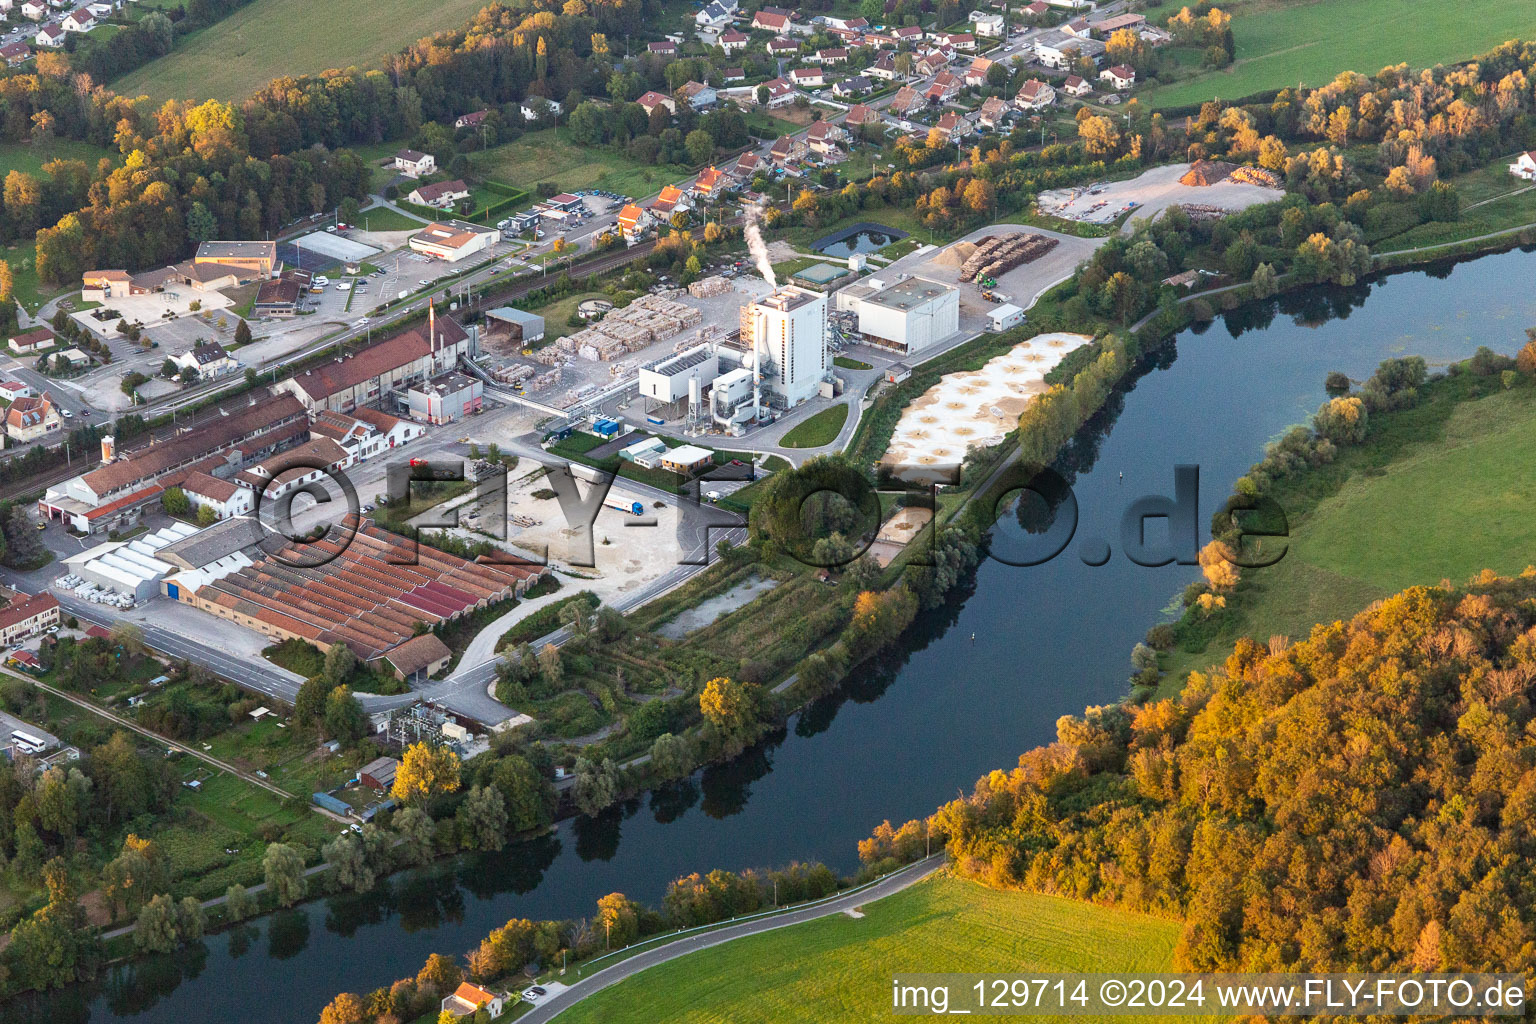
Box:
[561,875,1209,1024]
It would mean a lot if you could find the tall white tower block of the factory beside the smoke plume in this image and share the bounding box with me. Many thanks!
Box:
[742,286,828,407]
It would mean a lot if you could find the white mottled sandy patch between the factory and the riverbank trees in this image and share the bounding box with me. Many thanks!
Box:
[880,333,1092,482]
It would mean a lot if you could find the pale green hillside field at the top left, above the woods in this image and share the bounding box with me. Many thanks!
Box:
[112,0,485,103]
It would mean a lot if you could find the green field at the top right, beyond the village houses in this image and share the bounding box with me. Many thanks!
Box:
[1144,0,1536,106]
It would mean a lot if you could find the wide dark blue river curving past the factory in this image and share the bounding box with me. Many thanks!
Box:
[14,252,1536,1024]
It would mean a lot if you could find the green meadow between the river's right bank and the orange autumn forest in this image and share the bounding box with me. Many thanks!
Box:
[1163,374,1536,688]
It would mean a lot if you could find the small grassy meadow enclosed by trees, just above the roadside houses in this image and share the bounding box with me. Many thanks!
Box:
[470,127,690,200]
